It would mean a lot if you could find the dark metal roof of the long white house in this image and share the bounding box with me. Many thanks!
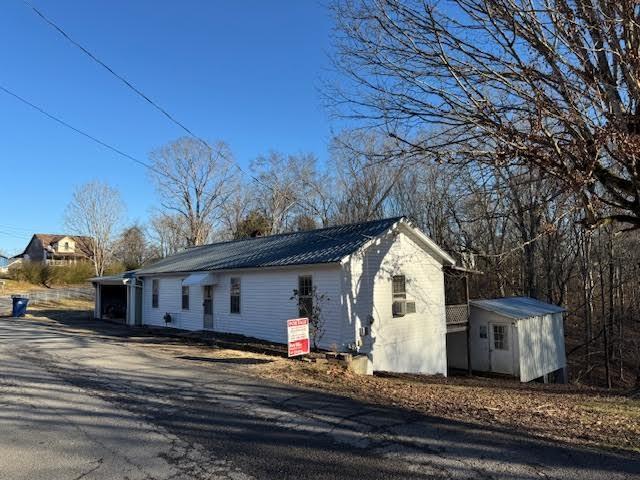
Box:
[137,217,403,276]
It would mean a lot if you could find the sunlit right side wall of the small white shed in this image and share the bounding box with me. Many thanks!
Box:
[518,313,566,382]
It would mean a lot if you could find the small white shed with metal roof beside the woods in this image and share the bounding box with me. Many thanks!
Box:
[447,297,566,382]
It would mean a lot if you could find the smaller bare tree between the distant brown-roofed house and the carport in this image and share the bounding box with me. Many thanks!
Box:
[65,181,124,276]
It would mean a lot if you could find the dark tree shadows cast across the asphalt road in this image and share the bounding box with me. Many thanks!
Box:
[0,317,640,480]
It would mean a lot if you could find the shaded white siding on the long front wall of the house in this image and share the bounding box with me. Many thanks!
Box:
[143,265,344,348]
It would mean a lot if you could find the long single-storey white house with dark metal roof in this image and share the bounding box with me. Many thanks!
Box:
[93,217,454,375]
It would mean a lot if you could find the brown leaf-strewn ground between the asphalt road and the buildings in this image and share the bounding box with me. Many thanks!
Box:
[25,301,640,452]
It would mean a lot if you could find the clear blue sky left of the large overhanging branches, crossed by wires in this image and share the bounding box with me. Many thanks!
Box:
[0,0,332,254]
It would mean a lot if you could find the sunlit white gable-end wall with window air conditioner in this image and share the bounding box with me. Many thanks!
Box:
[343,232,447,375]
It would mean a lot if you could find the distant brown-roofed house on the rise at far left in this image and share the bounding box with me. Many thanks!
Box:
[19,233,90,265]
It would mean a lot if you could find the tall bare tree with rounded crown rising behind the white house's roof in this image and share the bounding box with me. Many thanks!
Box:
[151,137,235,246]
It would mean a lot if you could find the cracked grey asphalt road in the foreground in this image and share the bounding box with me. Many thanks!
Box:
[0,318,640,480]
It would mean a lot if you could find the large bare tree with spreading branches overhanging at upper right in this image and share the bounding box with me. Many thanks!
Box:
[330,0,640,228]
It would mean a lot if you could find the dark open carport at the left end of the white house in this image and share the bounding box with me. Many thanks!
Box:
[91,271,142,325]
